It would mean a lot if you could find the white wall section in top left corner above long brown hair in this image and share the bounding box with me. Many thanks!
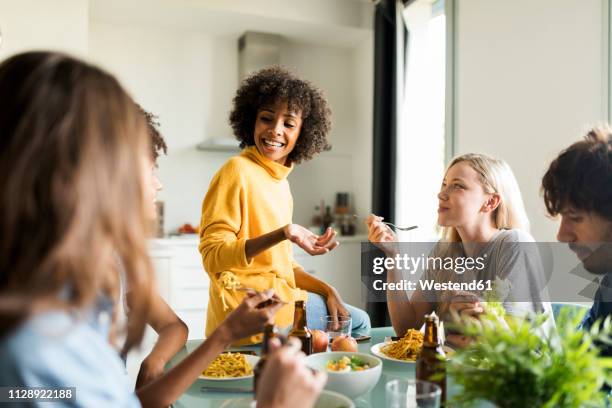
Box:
[0,0,89,60]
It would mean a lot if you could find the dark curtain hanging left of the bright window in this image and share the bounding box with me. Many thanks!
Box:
[366,0,398,327]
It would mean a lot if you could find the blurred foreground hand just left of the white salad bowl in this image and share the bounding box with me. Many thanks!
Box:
[255,338,327,408]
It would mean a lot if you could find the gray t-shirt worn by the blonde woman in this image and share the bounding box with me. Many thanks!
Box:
[422,229,554,330]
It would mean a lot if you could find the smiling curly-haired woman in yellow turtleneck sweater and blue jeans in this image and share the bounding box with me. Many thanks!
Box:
[199,67,370,344]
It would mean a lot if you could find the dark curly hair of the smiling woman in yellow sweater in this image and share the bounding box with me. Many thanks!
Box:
[229,66,331,164]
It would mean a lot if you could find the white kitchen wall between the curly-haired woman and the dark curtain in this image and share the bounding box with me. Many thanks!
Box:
[281,38,374,231]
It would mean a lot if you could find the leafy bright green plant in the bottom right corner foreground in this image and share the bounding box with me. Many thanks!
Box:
[448,311,612,408]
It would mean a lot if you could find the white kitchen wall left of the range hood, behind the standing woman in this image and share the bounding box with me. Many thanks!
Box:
[89,22,237,230]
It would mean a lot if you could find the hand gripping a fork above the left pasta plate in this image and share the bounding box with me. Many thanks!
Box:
[217,289,285,342]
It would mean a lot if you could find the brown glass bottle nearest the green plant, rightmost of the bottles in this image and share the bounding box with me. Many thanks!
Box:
[416,313,446,404]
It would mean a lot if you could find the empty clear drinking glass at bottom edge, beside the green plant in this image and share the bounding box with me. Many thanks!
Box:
[385,379,442,408]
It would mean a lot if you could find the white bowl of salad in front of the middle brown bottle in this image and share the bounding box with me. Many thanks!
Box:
[306,351,382,399]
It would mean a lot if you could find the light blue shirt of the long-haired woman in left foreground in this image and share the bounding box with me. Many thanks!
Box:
[0,301,140,407]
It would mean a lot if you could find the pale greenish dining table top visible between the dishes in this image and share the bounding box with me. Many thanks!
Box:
[170,327,478,408]
